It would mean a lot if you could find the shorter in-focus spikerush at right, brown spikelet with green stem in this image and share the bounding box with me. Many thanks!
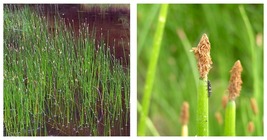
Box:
[224,60,243,136]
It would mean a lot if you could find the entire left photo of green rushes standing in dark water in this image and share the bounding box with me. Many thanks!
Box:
[3,4,130,136]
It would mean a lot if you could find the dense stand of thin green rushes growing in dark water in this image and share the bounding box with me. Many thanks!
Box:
[4,6,130,136]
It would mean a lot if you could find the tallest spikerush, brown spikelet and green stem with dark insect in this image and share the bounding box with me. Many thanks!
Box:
[192,34,212,136]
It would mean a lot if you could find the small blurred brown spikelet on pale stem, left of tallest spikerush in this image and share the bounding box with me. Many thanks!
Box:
[180,102,189,136]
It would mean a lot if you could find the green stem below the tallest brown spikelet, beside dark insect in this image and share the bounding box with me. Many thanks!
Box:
[197,78,209,136]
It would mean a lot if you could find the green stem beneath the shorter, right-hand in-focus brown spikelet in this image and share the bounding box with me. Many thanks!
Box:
[224,100,236,136]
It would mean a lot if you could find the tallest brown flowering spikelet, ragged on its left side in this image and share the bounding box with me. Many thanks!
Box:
[192,34,212,79]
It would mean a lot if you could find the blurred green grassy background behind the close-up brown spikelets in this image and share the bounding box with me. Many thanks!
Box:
[137,4,263,136]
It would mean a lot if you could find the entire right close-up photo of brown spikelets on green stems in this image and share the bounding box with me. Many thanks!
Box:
[137,4,264,136]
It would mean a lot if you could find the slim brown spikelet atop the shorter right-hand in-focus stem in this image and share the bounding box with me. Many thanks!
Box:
[228,60,243,100]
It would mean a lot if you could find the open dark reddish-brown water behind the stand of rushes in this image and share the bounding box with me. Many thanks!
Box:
[32,4,130,67]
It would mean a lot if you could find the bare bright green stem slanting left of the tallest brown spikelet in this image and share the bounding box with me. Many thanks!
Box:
[138,4,168,135]
